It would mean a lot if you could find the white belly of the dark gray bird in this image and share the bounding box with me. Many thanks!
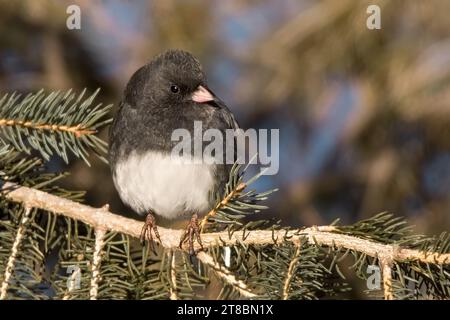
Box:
[113,152,215,219]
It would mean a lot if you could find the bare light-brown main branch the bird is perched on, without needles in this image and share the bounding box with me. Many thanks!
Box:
[2,182,450,264]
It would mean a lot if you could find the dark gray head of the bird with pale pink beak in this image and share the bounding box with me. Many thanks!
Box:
[124,50,213,108]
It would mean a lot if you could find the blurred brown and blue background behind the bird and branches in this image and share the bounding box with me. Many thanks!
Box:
[0,0,450,238]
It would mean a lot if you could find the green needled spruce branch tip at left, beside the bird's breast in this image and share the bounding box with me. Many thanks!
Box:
[0,90,112,164]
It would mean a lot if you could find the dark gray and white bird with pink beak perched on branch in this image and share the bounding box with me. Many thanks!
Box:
[108,49,239,255]
